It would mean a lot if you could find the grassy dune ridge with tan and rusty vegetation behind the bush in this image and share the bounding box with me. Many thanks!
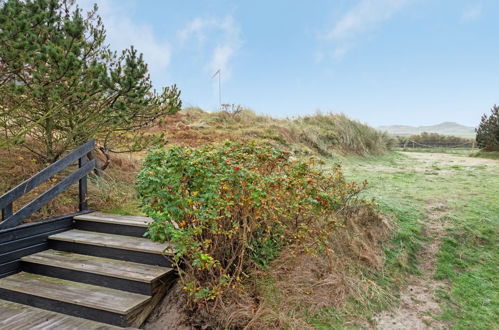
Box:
[156,108,393,157]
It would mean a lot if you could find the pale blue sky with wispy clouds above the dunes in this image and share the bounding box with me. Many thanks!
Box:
[78,0,499,126]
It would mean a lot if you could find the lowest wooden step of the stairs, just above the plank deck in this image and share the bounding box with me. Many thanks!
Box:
[0,272,151,327]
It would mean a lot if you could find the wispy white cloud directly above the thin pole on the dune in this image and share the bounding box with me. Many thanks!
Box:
[177,15,242,80]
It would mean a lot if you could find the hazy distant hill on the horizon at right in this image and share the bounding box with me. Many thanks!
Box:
[378,121,475,137]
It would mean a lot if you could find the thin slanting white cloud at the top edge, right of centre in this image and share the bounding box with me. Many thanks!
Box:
[320,0,410,59]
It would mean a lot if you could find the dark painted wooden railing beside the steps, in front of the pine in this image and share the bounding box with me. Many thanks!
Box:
[0,140,95,229]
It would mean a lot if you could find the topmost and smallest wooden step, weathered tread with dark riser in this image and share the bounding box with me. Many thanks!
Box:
[73,212,153,237]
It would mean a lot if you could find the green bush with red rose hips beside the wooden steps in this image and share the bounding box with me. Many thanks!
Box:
[137,142,364,303]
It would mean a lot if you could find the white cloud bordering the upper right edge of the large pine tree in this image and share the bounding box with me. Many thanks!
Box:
[78,0,171,86]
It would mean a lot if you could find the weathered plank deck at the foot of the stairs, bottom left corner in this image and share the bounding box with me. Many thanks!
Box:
[0,300,132,330]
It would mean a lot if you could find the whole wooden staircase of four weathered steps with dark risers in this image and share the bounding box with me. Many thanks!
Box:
[0,212,176,329]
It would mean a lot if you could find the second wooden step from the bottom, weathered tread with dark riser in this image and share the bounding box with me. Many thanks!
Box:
[21,250,175,295]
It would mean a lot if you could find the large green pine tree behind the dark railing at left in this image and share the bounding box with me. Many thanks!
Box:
[0,0,181,162]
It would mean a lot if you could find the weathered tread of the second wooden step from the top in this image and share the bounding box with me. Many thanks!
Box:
[49,229,172,254]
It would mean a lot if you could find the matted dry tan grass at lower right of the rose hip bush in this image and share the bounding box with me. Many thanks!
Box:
[248,210,391,329]
